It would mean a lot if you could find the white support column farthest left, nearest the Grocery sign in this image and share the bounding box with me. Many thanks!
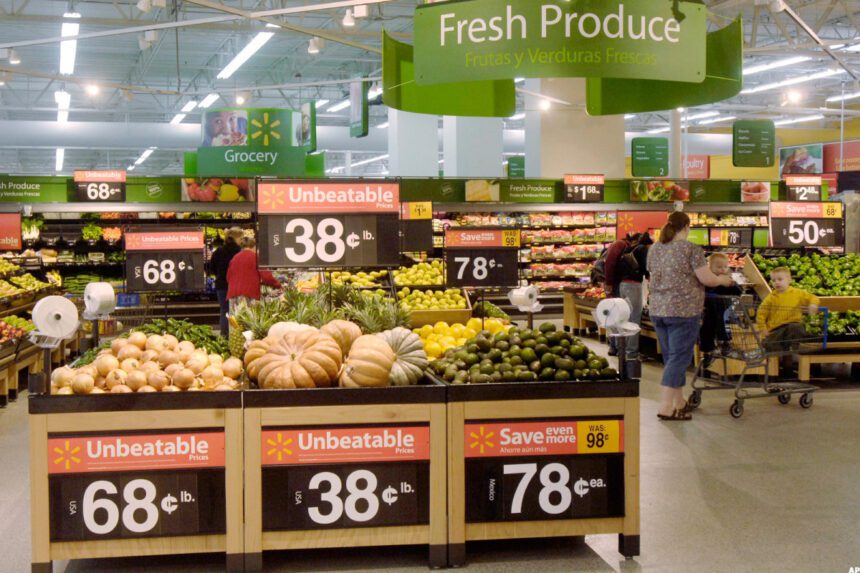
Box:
[387,109,439,177]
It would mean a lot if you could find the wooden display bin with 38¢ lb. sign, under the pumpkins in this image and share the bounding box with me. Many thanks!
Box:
[244,384,447,571]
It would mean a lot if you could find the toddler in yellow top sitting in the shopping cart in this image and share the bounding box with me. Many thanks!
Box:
[756,267,820,370]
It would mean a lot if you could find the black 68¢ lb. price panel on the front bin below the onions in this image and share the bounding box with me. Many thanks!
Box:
[49,469,226,541]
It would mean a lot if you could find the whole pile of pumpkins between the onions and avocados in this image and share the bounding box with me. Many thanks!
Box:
[244,320,428,389]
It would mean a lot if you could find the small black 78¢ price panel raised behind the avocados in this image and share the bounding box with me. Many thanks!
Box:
[445,249,519,287]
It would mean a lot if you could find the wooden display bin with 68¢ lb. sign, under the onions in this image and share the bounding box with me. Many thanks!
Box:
[29,392,243,573]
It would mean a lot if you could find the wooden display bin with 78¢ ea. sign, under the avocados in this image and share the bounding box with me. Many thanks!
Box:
[448,380,639,566]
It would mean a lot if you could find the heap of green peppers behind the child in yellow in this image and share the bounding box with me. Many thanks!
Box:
[752,253,860,296]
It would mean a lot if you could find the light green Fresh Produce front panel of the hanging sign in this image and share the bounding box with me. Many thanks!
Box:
[415,0,707,84]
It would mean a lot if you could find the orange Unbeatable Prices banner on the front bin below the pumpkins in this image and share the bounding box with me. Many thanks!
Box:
[261,426,430,466]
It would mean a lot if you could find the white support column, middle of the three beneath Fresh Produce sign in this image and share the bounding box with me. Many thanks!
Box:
[442,115,505,177]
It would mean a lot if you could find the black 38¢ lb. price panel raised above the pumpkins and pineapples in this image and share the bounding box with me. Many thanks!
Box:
[259,214,400,268]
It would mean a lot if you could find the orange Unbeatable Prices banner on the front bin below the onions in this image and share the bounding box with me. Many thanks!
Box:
[48,432,224,474]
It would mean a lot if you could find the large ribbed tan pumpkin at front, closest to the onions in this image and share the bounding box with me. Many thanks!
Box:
[245,330,343,388]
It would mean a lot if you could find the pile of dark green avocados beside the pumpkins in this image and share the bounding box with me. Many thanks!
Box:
[431,322,618,384]
